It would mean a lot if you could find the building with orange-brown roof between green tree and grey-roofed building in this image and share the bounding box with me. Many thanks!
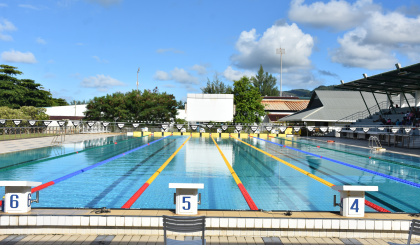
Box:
[261,96,309,123]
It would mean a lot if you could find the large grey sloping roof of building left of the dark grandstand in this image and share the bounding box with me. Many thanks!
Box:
[279,90,386,122]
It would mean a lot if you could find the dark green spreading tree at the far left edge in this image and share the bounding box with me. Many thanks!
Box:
[0,65,68,109]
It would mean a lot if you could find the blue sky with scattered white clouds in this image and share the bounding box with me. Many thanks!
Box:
[0,0,420,102]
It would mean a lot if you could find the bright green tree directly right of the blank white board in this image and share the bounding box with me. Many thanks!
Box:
[233,76,265,123]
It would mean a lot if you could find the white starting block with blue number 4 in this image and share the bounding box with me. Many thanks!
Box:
[332,185,378,217]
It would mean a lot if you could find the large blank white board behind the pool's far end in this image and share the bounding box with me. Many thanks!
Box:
[185,94,235,122]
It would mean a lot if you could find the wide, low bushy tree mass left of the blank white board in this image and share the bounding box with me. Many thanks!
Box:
[85,88,177,122]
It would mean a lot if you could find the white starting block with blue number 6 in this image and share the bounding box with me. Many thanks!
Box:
[0,181,42,213]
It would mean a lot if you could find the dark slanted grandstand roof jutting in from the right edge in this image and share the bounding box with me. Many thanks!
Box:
[335,63,420,94]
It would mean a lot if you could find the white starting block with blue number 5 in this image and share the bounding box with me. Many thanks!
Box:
[169,183,204,215]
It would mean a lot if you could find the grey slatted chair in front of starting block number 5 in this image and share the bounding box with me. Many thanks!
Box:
[163,215,206,245]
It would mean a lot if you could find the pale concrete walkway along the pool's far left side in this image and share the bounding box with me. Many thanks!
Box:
[0,134,119,154]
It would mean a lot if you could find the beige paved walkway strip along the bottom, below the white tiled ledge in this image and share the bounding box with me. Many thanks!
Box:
[0,235,420,245]
